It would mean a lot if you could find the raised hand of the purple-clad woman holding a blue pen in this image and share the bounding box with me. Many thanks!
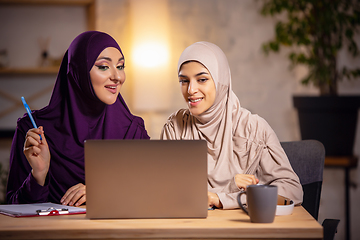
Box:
[24,127,50,186]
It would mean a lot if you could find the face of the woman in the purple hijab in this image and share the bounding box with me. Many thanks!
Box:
[90,47,125,105]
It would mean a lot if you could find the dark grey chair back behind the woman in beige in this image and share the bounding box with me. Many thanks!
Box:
[281,140,325,220]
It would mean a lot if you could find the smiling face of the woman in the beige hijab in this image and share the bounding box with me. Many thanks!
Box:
[179,62,216,116]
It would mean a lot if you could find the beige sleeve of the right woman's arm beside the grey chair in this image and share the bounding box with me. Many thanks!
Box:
[257,118,303,204]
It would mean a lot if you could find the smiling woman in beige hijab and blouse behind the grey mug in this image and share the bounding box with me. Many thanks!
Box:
[161,42,303,209]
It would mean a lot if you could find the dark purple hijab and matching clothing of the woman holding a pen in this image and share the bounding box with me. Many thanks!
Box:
[7,31,149,203]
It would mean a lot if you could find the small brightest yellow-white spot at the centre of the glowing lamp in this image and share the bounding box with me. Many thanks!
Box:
[133,42,169,68]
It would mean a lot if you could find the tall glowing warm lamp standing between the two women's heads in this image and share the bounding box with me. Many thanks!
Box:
[128,0,176,113]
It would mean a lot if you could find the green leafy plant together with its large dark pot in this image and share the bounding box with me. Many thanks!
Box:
[261,0,360,156]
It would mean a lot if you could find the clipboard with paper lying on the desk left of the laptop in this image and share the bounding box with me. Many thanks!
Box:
[0,202,86,217]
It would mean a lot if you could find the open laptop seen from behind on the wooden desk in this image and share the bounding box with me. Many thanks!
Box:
[85,140,208,219]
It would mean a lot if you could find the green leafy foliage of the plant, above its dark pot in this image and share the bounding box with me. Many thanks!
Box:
[261,0,360,95]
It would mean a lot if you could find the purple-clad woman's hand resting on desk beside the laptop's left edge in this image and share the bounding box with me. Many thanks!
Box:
[60,183,86,207]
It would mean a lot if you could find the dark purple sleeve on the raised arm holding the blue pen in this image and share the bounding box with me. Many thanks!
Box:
[6,121,49,204]
